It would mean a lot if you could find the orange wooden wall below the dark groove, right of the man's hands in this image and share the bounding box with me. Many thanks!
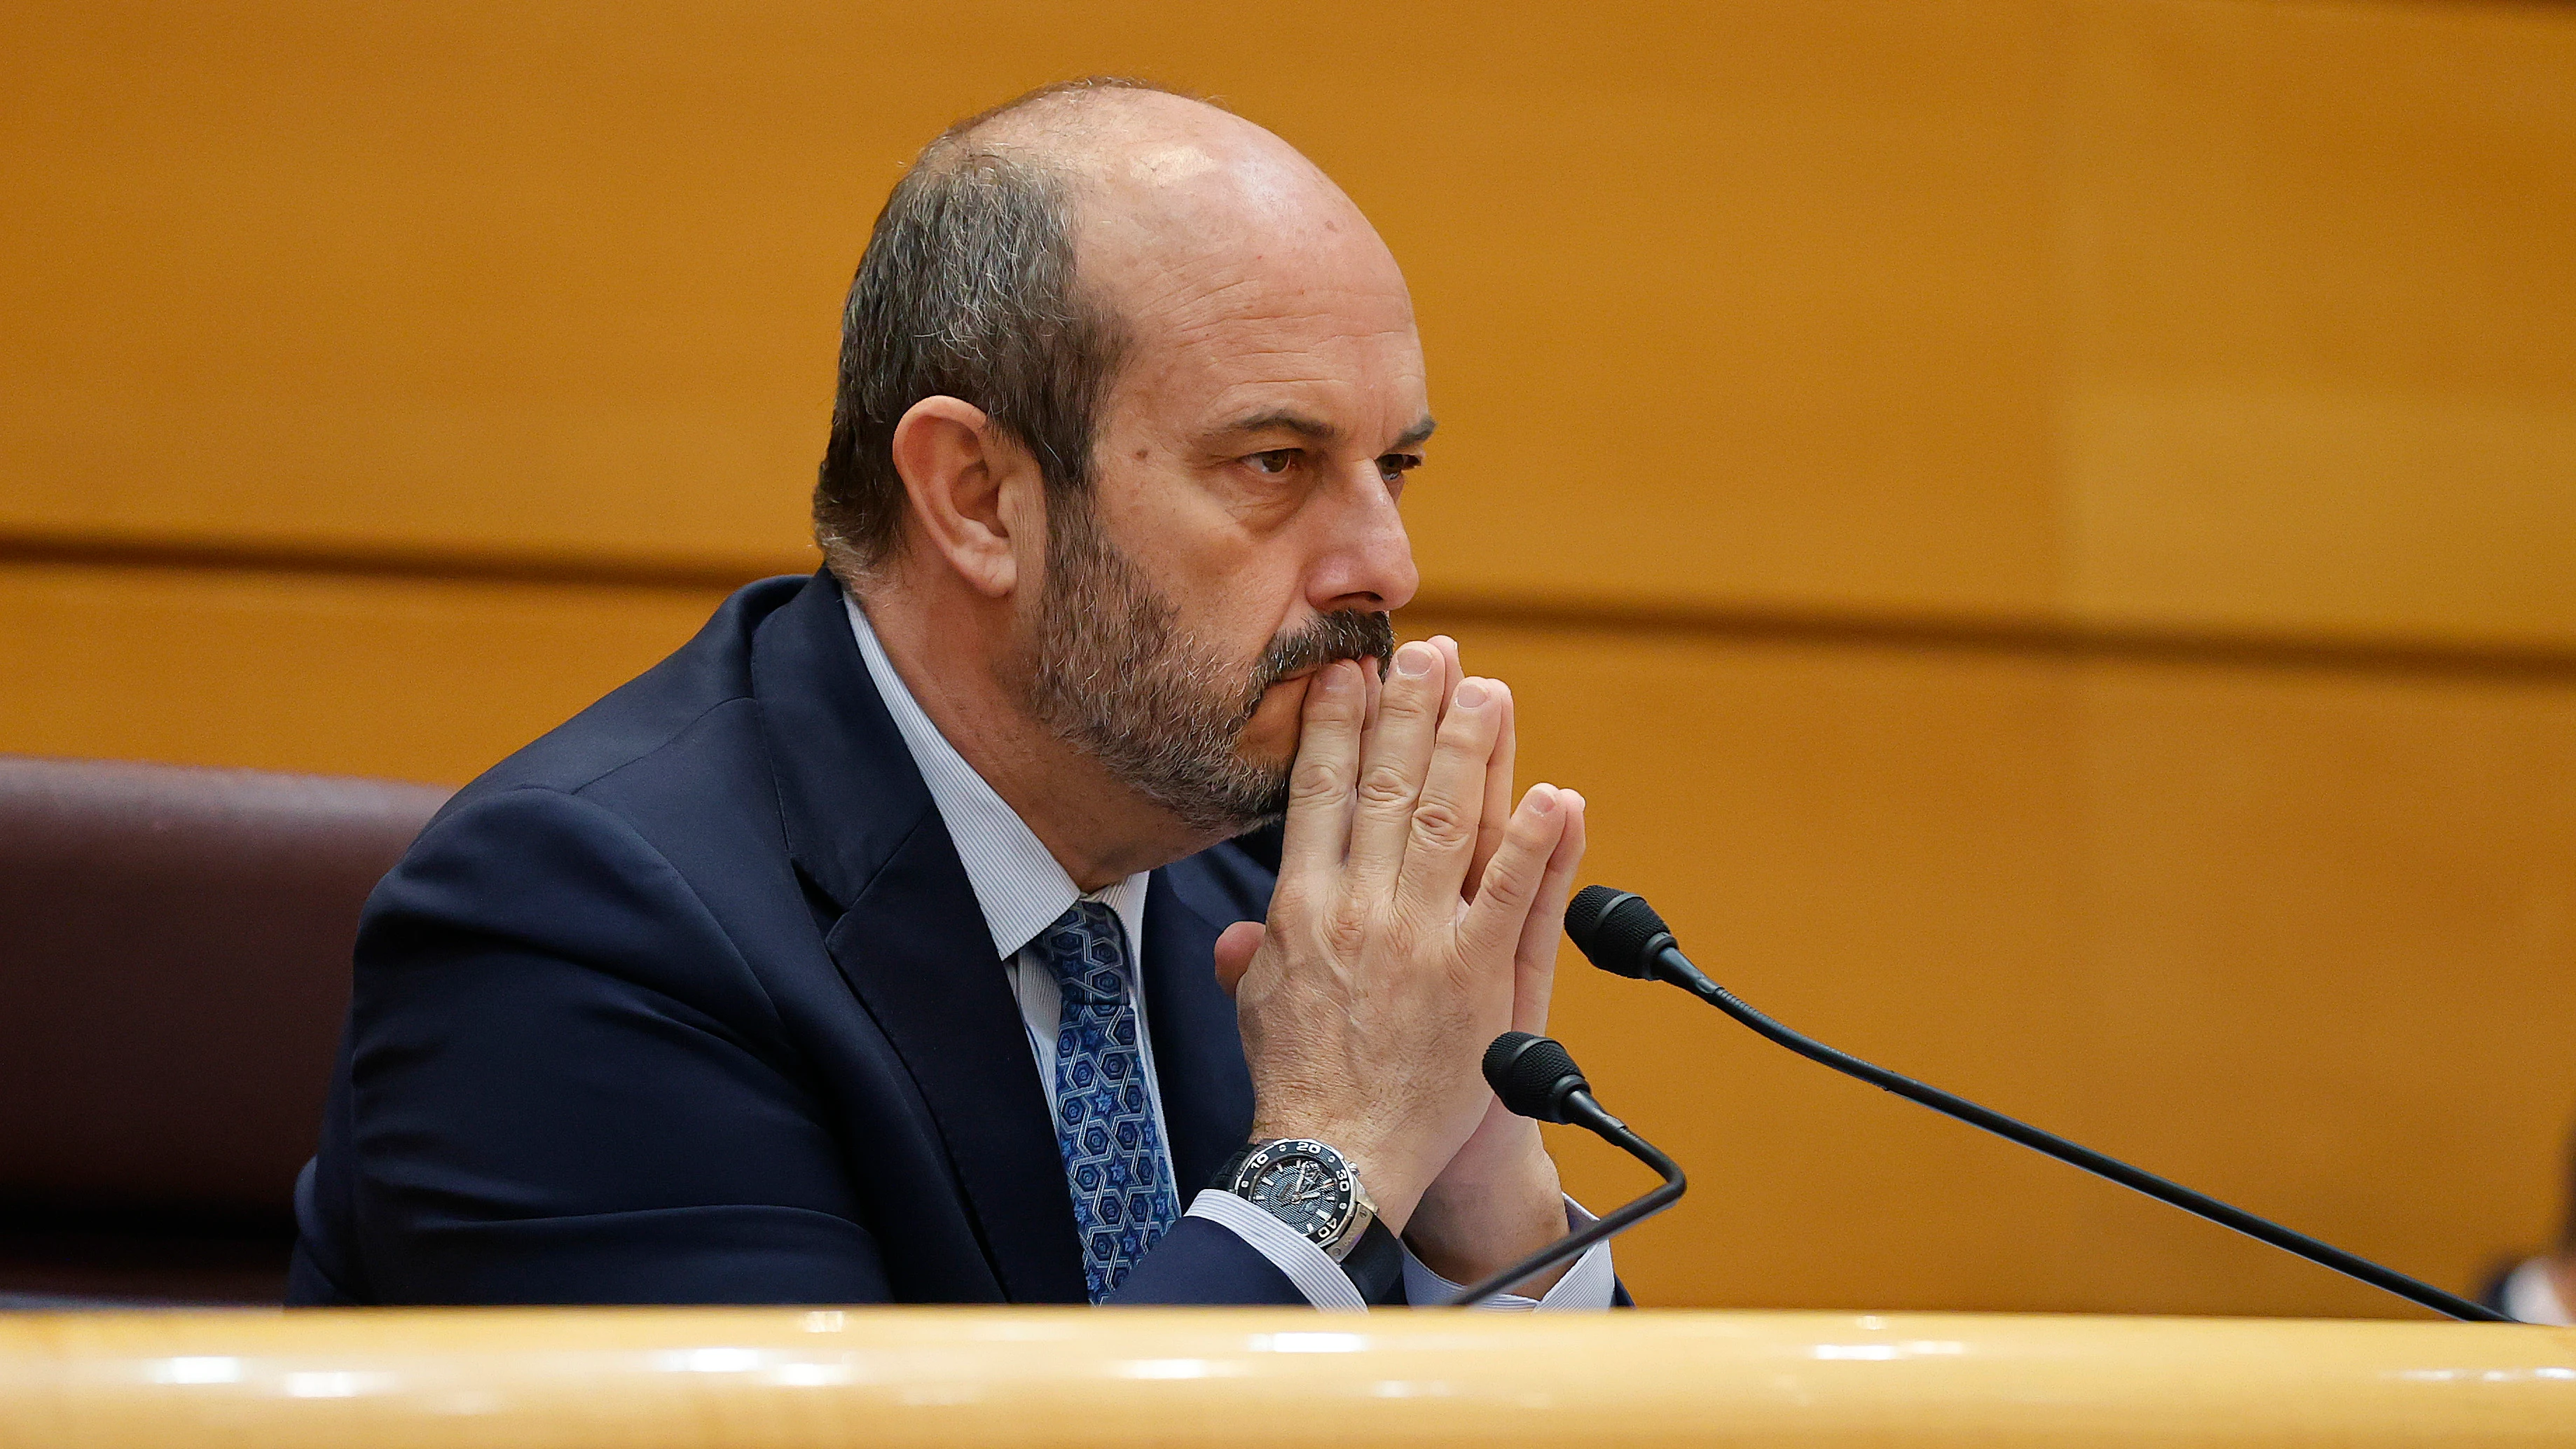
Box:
[1412,616,2576,1312]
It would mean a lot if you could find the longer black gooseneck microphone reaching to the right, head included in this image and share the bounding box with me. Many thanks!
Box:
[1566,884,2512,1323]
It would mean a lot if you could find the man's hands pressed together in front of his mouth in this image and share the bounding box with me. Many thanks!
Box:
[1216,640,1584,1282]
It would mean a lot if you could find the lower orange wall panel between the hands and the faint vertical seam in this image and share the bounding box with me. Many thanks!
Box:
[1442,616,2079,1307]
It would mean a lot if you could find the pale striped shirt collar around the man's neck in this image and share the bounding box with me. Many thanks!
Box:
[842,596,1152,962]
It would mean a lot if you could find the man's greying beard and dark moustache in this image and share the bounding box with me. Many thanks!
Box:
[1020,500,1396,838]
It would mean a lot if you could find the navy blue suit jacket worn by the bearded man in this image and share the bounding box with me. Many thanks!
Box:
[289,575,1304,1305]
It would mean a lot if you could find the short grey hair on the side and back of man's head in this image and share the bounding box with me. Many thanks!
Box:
[814,77,1162,580]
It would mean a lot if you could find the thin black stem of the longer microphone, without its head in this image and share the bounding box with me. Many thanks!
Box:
[1656,946,2512,1323]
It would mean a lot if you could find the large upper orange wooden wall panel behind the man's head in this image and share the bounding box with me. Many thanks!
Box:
[0,0,2053,608]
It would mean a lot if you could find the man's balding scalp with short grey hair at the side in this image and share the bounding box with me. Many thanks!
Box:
[814,77,1412,577]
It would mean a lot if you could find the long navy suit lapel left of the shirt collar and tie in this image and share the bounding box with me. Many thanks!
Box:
[752,575,1092,1302]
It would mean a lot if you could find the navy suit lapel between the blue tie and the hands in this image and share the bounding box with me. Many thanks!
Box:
[1138,864,1252,1196]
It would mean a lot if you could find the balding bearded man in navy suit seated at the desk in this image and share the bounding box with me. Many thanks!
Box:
[291,83,1615,1307]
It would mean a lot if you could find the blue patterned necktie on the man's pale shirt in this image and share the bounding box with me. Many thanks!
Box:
[1038,900,1177,1302]
